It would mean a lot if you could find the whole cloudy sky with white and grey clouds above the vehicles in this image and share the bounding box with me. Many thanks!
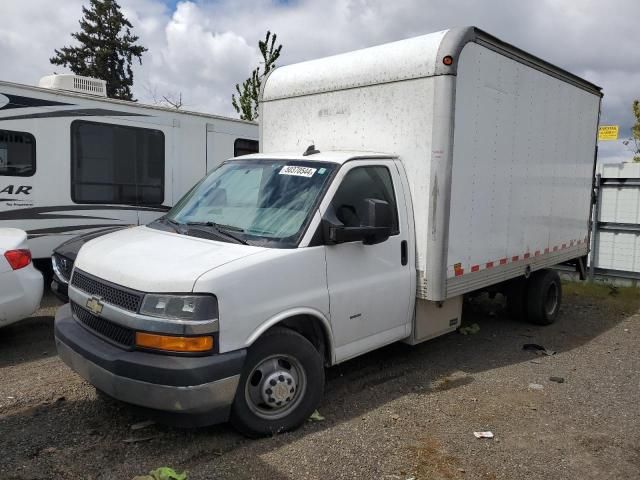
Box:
[0,0,640,160]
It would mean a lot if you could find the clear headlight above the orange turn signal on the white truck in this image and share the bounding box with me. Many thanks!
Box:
[140,293,218,320]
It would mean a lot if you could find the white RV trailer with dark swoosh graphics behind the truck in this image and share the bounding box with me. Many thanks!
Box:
[0,75,258,259]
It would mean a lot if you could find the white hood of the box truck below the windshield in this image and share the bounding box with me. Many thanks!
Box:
[75,227,266,293]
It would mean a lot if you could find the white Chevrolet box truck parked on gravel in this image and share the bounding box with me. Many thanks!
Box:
[55,27,602,435]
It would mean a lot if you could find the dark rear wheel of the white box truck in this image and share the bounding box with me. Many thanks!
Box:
[526,270,562,325]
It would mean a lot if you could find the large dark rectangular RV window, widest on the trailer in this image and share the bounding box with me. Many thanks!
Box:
[71,120,164,205]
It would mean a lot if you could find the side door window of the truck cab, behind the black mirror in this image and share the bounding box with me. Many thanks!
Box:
[331,166,400,235]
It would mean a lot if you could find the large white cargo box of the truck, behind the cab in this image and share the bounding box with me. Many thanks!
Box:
[260,27,602,301]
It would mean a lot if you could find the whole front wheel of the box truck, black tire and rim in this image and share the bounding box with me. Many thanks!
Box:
[230,328,324,437]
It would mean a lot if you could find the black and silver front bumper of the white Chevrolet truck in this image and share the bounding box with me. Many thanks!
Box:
[55,305,246,423]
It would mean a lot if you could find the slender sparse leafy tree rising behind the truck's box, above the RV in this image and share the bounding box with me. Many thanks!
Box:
[231,31,282,120]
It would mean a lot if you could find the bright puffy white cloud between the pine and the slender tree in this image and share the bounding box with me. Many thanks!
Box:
[130,2,258,115]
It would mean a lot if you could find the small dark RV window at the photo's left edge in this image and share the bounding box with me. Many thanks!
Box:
[0,130,36,177]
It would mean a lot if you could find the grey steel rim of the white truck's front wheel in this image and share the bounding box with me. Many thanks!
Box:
[245,354,307,420]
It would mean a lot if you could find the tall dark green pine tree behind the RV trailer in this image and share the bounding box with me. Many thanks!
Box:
[49,0,147,100]
